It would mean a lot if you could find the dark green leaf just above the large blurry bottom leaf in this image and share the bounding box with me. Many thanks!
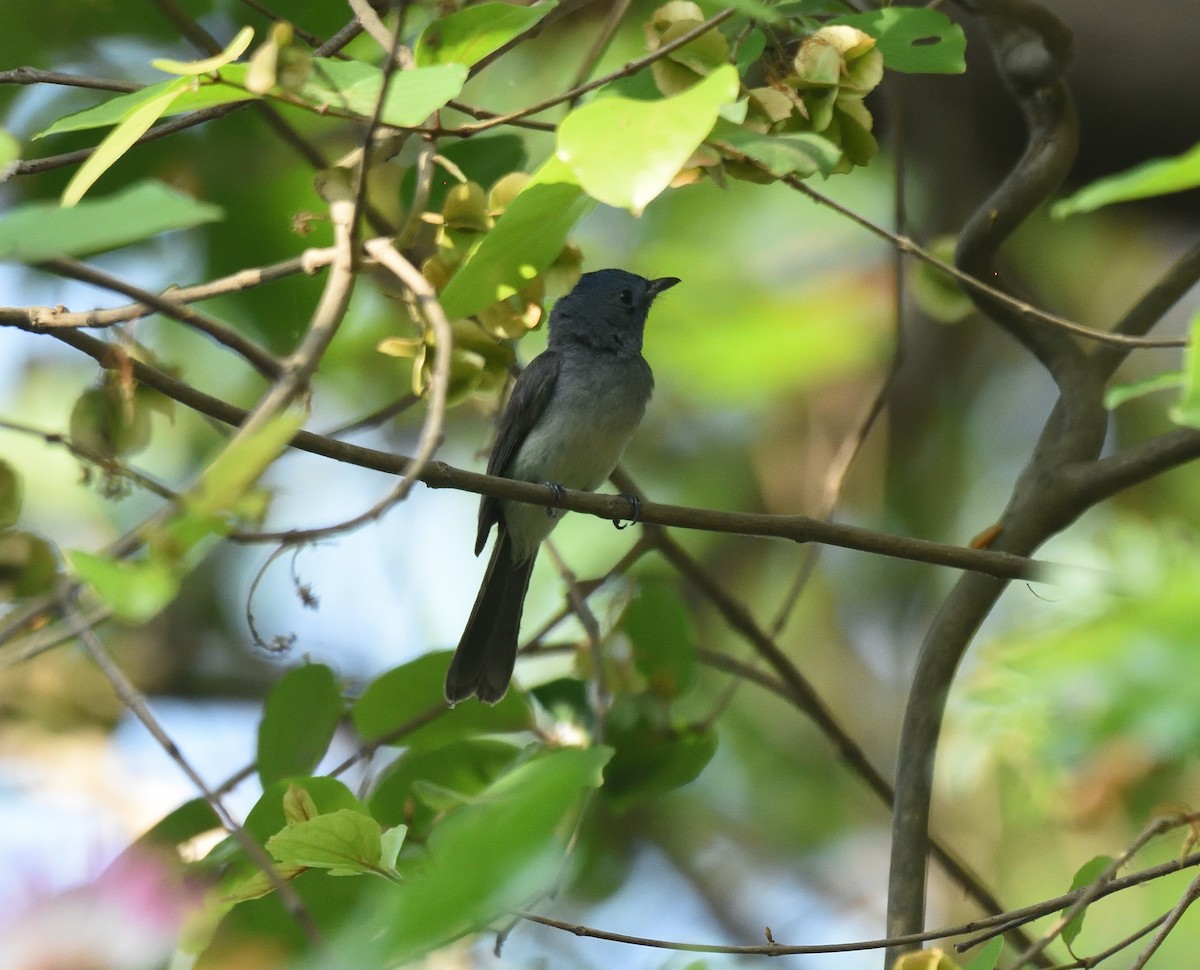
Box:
[367,738,522,833]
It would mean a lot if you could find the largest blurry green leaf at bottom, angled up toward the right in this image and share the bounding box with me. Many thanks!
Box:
[348,748,610,966]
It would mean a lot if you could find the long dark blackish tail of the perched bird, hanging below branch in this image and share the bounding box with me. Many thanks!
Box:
[445,523,536,705]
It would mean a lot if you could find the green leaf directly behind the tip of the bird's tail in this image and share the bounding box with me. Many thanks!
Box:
[350,652,533,750]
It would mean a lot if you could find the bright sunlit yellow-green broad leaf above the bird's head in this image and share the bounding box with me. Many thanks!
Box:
[557,64,738,215]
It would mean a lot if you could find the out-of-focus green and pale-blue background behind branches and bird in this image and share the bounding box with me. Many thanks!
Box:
[0,0,1200,968]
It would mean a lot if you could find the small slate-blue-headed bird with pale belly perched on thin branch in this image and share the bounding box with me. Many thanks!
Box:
[445,269,679,705]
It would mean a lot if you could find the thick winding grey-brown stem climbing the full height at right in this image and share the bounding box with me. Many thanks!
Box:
[888,0,1106,965]
